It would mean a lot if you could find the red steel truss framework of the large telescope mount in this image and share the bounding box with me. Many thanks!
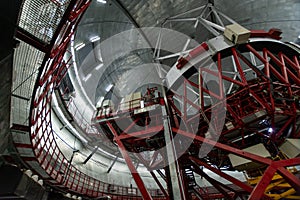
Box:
[96,39,300,200]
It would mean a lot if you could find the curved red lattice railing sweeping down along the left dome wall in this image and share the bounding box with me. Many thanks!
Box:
[20,0,165,200]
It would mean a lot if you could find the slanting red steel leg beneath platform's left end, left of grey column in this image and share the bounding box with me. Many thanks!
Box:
[107,122,152,200]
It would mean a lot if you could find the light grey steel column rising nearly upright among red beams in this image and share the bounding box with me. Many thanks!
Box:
[162,105,186,200]
